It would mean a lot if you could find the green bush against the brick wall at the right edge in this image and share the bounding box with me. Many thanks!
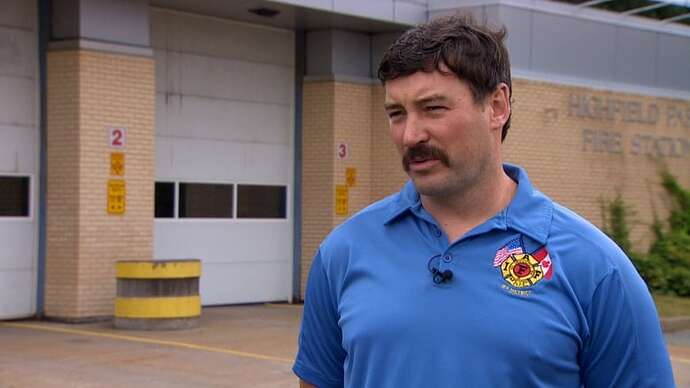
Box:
[602,172,690,296]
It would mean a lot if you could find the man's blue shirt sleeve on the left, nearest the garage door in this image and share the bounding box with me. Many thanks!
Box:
[292,251,345,388]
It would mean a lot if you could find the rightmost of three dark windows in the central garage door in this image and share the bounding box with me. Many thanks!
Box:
[237,185,287,218]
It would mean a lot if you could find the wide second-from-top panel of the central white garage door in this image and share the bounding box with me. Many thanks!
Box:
[168,53,294,105]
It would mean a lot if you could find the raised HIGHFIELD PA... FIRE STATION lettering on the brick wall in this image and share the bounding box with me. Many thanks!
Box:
[564,94,690,158]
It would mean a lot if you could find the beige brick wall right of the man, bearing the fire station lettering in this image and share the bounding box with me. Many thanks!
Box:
[504,79,690,249]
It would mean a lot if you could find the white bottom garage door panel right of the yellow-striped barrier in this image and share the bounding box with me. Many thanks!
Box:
[199,262,292,305]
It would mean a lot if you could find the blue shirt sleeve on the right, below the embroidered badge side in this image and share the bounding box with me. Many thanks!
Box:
[580,266,675,388]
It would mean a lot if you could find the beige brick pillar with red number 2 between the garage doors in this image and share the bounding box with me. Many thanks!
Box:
[45,50,155,319]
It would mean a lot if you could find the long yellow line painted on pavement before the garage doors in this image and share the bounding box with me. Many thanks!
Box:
[0,322,294,363]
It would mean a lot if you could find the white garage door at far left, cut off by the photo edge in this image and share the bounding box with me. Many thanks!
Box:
[0,0,39,319]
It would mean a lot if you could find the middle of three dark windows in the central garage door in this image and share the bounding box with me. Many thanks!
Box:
[179,183,233,218]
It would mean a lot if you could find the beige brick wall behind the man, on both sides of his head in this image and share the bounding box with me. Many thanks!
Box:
[302,79,690,294]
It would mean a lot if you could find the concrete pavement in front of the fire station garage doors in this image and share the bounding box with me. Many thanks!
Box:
[0,304,690,388]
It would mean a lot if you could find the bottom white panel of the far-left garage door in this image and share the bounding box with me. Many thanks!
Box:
[0,269,36,319]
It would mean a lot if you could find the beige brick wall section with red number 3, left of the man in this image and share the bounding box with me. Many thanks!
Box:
[301,81,372,296]
